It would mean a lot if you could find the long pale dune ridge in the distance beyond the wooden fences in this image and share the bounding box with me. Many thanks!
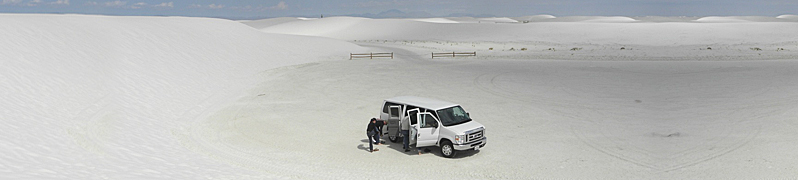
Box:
[261,17,796,45]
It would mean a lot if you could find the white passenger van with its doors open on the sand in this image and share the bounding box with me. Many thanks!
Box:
[380,96,488,158]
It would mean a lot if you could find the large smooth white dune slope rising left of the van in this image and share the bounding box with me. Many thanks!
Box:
[0,14,362,179]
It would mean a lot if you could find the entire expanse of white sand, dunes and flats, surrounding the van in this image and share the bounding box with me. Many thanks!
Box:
[0,14,798,179]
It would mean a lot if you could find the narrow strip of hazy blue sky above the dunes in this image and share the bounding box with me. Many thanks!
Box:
[0,0,798,19]
